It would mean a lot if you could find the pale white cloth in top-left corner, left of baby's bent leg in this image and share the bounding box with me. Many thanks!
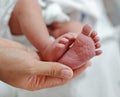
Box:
[0,0,16,39]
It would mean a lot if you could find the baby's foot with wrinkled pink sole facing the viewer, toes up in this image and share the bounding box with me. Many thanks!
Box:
[59,25,102,69]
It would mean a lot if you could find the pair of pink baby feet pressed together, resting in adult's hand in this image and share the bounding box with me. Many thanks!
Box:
[43,25,102,69]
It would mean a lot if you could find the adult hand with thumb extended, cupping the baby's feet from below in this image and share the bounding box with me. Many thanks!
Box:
[0,39,88,90]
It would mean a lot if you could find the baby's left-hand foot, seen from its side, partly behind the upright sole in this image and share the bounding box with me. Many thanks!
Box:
[41,33,77,61]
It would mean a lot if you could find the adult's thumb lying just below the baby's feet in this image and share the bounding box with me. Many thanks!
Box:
[32,61,73,79]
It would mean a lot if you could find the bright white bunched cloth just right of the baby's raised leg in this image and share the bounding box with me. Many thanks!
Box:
[39,0,70,25]
